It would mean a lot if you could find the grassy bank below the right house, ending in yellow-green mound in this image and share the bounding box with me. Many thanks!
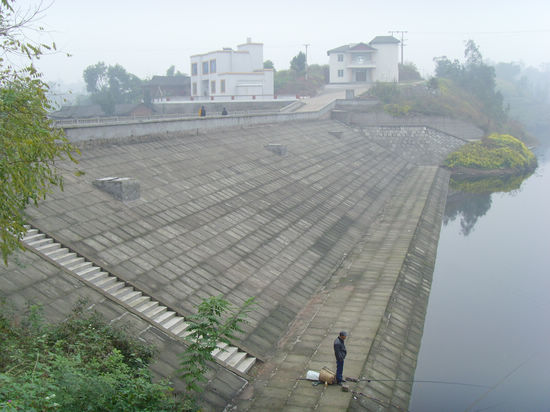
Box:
[369,79,537,175]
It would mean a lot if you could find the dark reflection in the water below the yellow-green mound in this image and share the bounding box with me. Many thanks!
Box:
[443,173,531,236]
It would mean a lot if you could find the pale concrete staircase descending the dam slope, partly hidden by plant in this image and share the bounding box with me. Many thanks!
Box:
[22,226,256,374]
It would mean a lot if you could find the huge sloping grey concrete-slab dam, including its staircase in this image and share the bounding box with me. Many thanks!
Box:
[0,102,478,411]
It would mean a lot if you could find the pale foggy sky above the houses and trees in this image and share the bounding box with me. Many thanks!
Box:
[11,0,550,87]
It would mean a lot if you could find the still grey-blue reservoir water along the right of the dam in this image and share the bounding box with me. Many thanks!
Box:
[409,149,550,412]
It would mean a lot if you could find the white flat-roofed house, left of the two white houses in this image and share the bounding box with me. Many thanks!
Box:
[191,38,274,100]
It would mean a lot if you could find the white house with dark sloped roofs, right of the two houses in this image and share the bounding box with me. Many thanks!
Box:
[327,36,400,84]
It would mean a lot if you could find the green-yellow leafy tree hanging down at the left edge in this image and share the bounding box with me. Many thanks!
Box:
[0,0,78,264]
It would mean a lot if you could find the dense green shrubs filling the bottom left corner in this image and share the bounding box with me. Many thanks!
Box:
[0,304,181,411]
